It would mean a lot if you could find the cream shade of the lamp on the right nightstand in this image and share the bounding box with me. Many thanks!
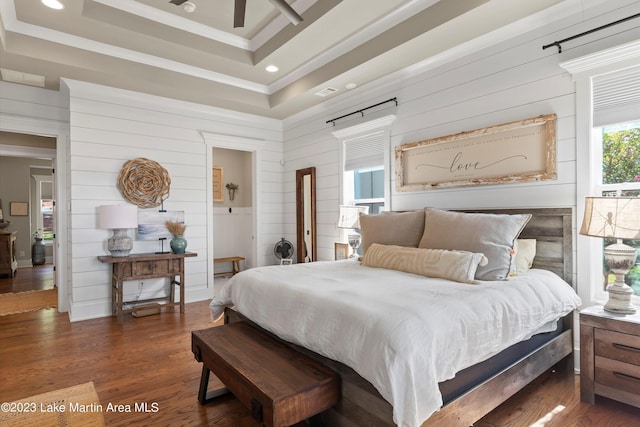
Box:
[580,197,640,239]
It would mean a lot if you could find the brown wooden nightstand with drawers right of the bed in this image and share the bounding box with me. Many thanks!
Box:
[580,306,640,408]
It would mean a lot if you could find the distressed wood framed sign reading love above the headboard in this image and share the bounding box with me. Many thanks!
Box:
[395,114,557,191]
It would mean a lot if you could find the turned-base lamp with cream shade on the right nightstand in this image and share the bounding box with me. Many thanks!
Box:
[580,197,640,314]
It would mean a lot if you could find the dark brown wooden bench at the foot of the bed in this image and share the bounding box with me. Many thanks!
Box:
[191,322,340,427]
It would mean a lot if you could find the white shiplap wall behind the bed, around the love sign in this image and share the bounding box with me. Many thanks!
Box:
[284,0,639,278]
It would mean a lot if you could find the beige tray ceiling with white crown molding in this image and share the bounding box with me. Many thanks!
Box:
[0,0,568,119]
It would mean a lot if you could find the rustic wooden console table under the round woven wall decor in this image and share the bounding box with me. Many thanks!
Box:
[98,252,198,320]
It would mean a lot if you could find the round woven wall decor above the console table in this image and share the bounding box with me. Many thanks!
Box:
[118,157,171,208]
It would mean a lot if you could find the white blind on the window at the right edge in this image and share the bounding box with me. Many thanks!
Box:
[593,67,640,127]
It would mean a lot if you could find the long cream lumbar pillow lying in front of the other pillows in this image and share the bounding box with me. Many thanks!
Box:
[362,243,487,283]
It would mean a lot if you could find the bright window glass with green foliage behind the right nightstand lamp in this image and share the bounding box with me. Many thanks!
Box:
[593,120,640,296]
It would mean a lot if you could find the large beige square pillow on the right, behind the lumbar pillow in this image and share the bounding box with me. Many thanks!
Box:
[418,208,531,280]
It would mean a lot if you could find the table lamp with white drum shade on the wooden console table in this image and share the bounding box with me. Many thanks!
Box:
[98,205,138,257]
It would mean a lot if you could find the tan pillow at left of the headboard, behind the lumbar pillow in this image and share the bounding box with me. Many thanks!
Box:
[360,210,424,254]
